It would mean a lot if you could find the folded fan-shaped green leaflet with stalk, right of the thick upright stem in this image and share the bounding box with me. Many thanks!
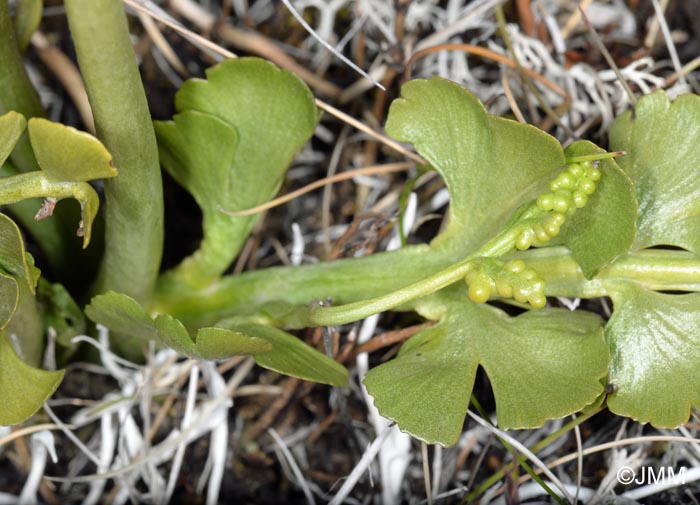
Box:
[155,58,318,287]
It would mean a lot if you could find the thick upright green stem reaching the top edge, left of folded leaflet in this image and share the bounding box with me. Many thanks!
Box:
[65,0,163,300]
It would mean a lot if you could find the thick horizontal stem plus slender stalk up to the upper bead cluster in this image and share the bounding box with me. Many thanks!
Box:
[153,216,540,328]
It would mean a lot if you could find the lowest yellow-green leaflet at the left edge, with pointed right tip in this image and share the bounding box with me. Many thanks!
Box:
[0,332,65,426]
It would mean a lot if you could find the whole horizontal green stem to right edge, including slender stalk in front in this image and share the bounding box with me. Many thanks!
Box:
[157,241,700,327]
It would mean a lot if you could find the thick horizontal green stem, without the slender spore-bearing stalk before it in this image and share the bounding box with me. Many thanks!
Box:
[150,245,438,327]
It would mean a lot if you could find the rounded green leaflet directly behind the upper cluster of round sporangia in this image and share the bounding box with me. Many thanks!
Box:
[558,141,637,278]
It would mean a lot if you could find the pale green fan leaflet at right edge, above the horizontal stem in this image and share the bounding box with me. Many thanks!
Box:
[610,91,700,255]
